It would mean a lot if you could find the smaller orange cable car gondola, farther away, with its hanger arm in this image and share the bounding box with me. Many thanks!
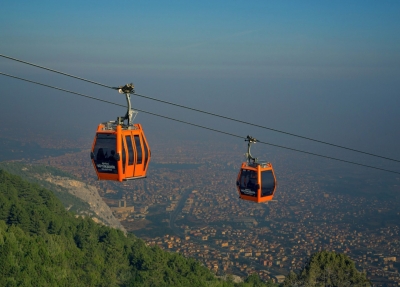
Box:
[236,136,277,203]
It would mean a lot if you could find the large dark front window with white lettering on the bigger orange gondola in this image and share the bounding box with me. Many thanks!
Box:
[93,134,118,173]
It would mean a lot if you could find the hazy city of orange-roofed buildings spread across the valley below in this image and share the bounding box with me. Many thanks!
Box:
[1,133,400,286]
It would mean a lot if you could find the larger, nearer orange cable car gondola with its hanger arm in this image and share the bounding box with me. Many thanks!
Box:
[90,84,151,181]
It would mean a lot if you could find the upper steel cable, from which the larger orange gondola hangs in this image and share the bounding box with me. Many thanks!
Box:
[0,54,400,162]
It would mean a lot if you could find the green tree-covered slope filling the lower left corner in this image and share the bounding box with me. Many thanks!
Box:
[0,170,278,286]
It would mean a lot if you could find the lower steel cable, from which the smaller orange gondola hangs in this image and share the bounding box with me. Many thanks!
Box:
[0,72,400,174]
